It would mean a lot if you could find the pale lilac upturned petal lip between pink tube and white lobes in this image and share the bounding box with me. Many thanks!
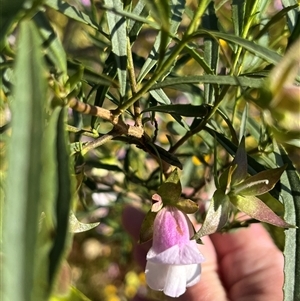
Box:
[147,240,204,265]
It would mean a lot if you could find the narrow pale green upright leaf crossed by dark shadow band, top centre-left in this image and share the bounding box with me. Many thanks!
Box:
[105,0,127,97]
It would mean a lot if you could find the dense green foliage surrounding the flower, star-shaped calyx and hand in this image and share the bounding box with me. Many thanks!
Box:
[0,0,300,301]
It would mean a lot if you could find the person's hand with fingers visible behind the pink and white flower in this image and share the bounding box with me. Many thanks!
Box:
[123,207,283,301]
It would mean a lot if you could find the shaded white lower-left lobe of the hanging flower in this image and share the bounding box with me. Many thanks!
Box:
[145,261,170,291]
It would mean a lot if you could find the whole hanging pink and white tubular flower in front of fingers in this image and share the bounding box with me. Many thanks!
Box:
[145,206,204,297]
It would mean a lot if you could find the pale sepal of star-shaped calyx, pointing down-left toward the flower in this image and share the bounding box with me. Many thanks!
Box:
[193,189,230,239]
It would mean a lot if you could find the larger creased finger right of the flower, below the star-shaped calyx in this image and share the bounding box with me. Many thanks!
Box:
[211,224,283,301]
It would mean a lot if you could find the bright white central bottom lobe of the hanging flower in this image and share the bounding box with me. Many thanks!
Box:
[164,265,186,297]
